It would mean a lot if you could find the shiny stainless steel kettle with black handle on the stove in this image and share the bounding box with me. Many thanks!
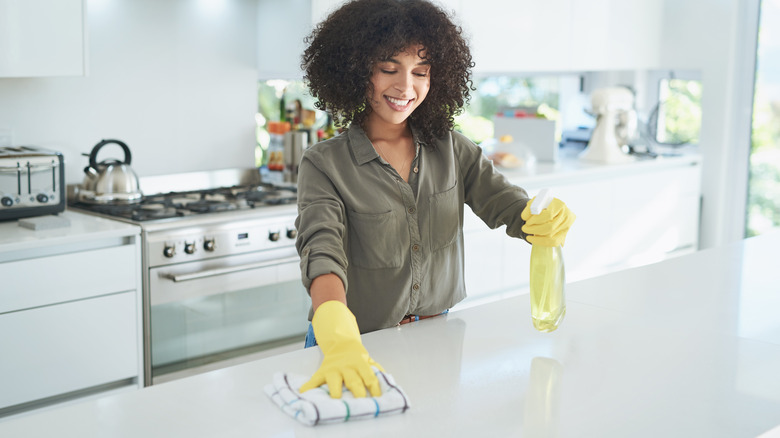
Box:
[79,139,143,204]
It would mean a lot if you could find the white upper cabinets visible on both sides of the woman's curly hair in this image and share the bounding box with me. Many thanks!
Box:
[258,0,663,79]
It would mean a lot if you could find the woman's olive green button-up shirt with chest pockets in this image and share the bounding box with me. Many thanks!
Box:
[296,126,528,333]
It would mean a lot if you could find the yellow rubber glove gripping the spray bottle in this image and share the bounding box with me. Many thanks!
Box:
[520,196,577,247]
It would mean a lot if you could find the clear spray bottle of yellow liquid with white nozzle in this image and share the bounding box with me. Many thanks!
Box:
[531,189,566,332]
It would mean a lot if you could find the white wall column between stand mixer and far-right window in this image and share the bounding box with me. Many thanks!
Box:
[661,0,759,248]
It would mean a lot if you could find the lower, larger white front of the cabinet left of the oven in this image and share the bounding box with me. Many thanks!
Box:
[0,291,139,409]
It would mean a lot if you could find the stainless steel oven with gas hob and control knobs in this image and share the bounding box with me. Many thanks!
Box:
[71,171,310,385]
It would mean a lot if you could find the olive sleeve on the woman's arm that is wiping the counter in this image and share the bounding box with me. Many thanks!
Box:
[295,150,347,293]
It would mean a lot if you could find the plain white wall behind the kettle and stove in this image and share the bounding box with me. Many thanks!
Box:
[0,0,257,183]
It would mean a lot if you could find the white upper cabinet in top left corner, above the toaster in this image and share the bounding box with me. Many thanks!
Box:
[0,0,85,77]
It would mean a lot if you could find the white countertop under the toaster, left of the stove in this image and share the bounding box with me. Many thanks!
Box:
[0,209,141,253]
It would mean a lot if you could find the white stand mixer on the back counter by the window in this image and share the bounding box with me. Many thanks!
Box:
[579,87,636,164]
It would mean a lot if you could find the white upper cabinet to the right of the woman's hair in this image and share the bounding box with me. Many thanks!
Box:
[450,0,663,74]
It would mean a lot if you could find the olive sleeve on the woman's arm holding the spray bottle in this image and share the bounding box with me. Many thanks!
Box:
[453,132,529,239]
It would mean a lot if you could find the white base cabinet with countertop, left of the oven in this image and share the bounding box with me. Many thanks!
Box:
[0,211,143,416]
